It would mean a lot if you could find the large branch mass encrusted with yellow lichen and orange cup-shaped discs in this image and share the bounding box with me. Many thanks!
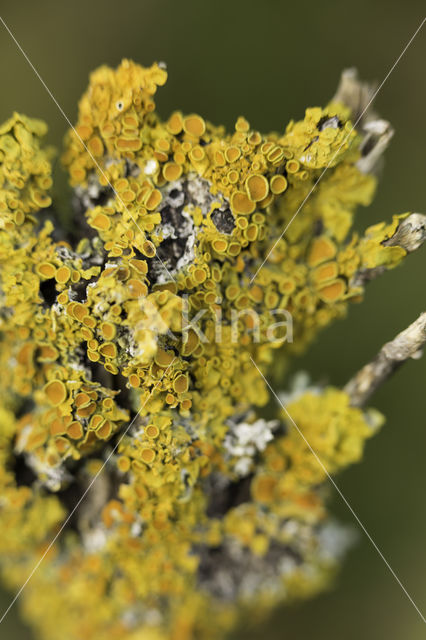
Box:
[0,60,424,640]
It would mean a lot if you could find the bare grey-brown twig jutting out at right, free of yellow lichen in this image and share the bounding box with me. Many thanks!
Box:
[344,312,426,407]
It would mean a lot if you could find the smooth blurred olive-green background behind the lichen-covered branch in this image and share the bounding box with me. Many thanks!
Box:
[0,0,426,640]
